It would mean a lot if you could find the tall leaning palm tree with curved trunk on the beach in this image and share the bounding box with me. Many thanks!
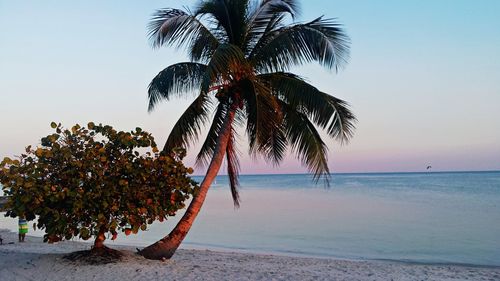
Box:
[140,0,356,259]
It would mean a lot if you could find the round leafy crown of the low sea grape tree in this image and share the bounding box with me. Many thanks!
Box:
[0,123,197,248]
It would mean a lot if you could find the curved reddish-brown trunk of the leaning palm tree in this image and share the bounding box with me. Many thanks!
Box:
[139,109,235,259]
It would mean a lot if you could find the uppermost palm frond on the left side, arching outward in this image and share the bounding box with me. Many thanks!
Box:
[148,9,219,61]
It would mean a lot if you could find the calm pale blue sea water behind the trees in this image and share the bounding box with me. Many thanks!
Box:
[0,172,500,266]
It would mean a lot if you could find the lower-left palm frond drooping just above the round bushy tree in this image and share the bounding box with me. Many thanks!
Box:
[163,93,211,151]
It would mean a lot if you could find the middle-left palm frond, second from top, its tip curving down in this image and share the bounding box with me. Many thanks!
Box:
[148,62,207,112]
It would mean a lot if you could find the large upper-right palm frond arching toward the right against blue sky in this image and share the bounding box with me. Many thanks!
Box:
[250,17,350,73]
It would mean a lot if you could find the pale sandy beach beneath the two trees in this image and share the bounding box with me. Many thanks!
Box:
[0,230,500,281]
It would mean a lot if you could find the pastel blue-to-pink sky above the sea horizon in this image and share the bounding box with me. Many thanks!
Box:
[0,0,500,173]
